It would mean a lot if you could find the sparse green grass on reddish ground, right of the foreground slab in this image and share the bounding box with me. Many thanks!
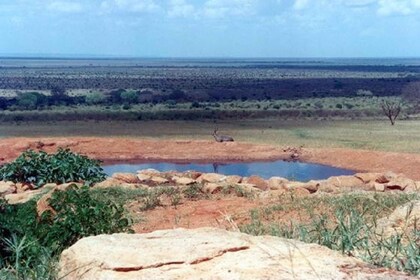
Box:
[240,194,420,276]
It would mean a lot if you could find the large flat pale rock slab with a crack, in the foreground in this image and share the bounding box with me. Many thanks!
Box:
[59,228,414,280]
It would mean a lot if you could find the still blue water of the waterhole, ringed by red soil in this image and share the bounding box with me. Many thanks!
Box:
[103,160,355,182]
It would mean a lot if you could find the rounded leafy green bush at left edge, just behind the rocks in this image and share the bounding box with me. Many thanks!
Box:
[0,149,105,187]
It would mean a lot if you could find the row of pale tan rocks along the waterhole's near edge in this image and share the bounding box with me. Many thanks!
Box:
[0,169,420,204]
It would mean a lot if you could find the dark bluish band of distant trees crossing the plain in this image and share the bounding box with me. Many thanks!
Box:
[0,76,419,102]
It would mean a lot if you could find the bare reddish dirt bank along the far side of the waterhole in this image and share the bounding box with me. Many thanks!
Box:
[0,137,420,180]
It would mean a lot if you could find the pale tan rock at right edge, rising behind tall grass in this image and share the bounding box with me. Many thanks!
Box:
[375,200,420,238]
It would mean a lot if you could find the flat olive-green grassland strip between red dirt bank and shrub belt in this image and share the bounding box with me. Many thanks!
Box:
[0,119,420,153]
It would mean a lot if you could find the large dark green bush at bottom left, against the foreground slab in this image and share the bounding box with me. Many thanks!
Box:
[0,186,131,279]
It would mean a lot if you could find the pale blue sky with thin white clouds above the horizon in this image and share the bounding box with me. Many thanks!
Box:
[0,0,420,57]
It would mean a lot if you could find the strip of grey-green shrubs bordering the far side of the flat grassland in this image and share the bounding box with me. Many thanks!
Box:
[0,94,412,122]
